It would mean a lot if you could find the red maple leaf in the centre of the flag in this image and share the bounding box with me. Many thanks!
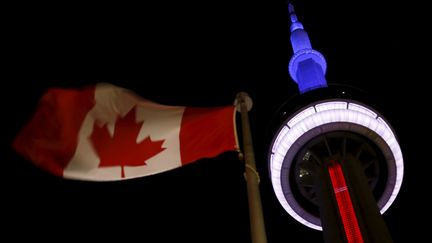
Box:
[90,108,165,178]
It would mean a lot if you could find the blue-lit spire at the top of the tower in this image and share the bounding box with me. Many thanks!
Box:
[288,3,327,93]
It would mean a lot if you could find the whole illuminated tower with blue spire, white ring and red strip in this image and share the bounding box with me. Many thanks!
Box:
[269,4,403,243]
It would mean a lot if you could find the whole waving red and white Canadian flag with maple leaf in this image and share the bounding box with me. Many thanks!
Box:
[13,84,238,181]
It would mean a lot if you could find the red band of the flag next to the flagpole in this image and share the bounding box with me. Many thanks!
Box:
[180,106,237,164]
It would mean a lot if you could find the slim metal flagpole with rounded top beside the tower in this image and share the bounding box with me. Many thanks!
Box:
[235,92,267,243]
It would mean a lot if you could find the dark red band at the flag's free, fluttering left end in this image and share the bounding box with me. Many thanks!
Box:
[12,86,95,176]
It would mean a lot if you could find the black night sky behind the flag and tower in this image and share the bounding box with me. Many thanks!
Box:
[0,0,430,243]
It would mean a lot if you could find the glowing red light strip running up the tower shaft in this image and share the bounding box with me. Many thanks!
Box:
[328,161,364,243]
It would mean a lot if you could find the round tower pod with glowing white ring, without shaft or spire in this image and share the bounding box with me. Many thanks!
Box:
[268,86,403,230]
